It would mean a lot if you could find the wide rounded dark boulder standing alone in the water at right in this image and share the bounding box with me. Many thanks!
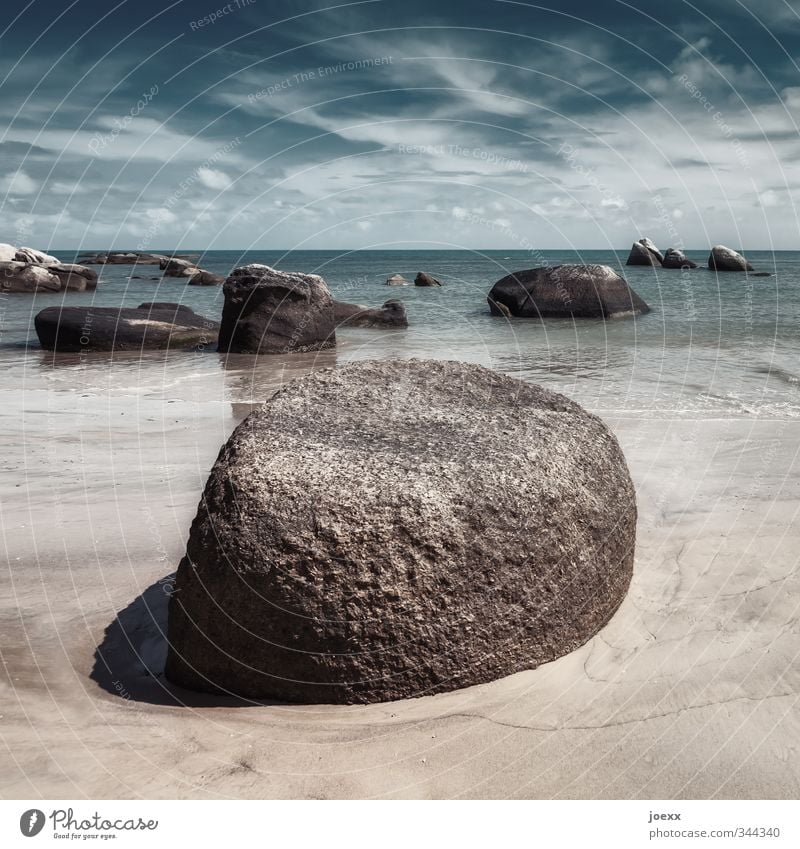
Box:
[488,265,650,318]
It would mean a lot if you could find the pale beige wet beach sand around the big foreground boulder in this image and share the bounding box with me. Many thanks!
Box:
[0,360,800,798]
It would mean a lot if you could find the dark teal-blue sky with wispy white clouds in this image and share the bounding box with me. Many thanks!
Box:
[0,0,800,250]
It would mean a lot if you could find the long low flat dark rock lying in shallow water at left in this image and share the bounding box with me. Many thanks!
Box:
[34,303,219,351]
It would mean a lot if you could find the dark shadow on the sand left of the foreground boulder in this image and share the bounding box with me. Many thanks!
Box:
[90,573,278,708]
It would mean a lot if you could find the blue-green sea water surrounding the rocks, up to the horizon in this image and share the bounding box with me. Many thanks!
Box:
[0,250,800,419]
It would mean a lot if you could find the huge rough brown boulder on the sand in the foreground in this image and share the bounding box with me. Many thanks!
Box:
[166,360,636,703]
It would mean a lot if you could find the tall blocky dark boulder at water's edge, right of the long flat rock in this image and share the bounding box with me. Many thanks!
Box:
[219,264,336,354]
